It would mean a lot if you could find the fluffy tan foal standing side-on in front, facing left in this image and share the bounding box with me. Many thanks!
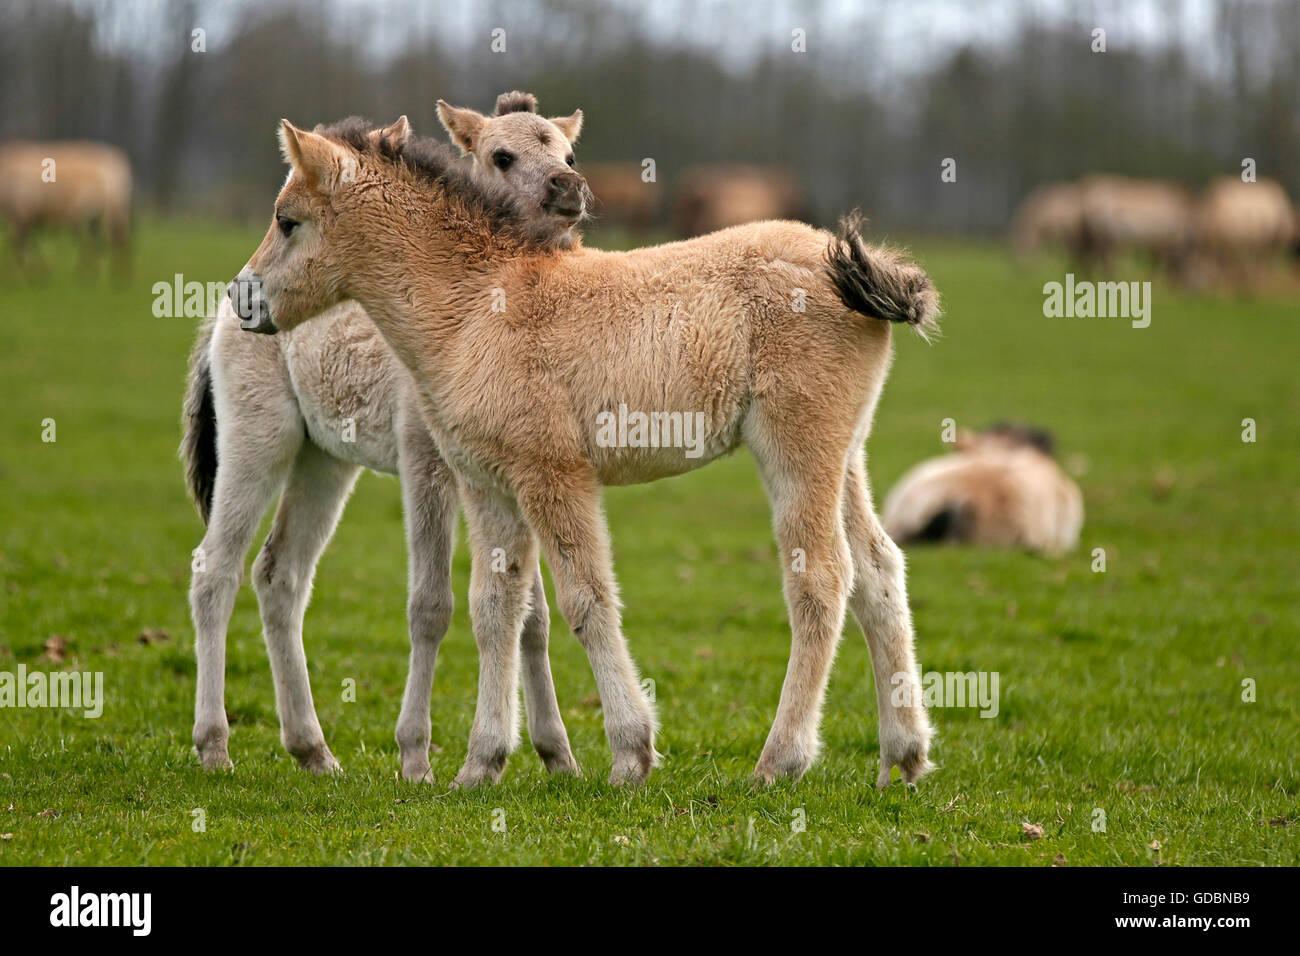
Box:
[231,120,939,786]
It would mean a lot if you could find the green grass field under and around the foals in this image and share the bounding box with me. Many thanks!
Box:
[0,224,1300,866]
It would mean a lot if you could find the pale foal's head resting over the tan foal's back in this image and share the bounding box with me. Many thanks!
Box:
[438,91,590,229]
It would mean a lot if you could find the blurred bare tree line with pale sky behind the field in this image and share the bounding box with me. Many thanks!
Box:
[0,0,1300,232]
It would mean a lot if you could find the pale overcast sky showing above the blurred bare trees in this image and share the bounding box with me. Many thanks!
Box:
[63,0,1227,79]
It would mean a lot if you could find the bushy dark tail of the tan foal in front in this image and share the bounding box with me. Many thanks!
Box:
[826,212,939,341]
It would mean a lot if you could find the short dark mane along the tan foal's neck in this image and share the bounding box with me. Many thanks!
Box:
[313,116,550,246]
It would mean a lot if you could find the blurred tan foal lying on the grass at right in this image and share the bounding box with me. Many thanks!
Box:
[881,424,1083,554]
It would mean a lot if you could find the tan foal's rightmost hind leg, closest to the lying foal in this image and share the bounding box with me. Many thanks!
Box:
[844,460,932,787]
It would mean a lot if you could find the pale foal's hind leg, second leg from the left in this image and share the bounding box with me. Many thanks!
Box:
[252,442,360,774]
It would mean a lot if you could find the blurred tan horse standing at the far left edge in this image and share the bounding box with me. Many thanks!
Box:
[0,142,131,272]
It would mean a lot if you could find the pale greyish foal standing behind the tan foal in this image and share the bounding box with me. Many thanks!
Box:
[181,92,585,780]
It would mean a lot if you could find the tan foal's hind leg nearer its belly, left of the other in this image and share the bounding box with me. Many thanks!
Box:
[751,442,853,783]
